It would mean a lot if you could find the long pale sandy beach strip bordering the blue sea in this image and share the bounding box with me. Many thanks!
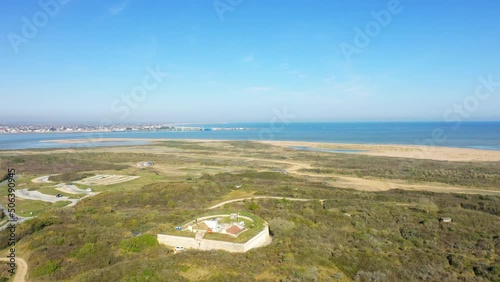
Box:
[40,138,500,162]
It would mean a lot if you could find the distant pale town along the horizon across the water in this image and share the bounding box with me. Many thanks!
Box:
[0,124,254,134]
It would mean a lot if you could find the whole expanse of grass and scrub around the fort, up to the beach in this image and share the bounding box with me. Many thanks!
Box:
[0,141,500,281]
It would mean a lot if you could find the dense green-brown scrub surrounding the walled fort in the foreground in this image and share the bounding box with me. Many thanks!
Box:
[0,173,500,281]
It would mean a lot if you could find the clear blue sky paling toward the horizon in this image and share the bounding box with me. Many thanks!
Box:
[0,0,500,123]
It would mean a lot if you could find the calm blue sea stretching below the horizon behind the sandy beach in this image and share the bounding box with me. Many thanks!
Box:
[0,122,500,150]
